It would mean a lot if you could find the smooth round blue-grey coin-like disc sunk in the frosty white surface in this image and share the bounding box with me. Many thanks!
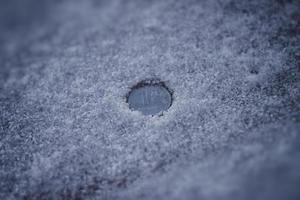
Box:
[127,83,172,115]
